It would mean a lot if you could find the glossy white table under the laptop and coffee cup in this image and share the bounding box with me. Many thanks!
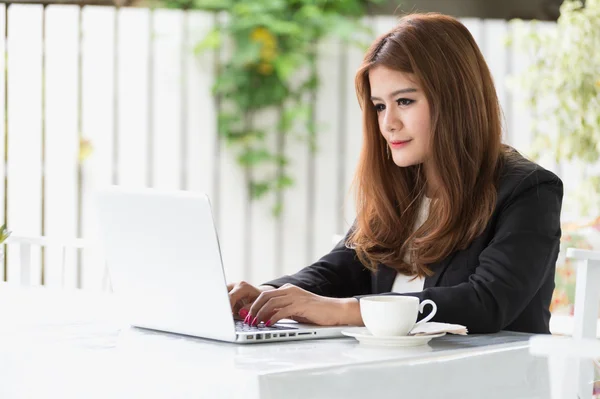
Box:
[0,284,550,399]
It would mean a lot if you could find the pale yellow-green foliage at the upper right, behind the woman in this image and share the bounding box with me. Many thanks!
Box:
[510,0,600,219]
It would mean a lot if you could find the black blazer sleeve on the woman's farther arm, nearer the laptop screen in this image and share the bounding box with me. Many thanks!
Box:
[264,229,371,298]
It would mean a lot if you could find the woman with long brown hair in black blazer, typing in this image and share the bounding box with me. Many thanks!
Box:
[229,14,563,333]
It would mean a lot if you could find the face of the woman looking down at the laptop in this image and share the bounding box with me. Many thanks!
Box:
[369,65,431,167]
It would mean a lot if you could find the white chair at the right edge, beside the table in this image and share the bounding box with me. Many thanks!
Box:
[529,248,600,399]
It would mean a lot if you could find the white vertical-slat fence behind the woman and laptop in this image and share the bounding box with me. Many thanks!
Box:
[0,4,564,289]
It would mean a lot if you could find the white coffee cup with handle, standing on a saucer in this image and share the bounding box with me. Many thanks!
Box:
[360,295,437,337]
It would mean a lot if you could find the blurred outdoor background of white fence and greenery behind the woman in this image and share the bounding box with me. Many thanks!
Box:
[0,0,600,322]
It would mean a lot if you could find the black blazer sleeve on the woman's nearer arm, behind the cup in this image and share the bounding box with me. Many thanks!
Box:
[358,178,563,333]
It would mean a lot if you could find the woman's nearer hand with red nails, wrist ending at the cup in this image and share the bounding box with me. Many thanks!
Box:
[245,284,362,327]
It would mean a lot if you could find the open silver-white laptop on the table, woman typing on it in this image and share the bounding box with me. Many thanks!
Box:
[95,186,343,344]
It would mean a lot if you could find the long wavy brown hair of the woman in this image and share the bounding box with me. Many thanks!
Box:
[348,13,504,276]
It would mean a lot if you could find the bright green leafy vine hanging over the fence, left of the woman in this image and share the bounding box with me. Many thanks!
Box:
[166,0,381,214]
